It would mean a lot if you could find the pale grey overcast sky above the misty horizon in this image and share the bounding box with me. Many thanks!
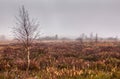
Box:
[0,0,120,37]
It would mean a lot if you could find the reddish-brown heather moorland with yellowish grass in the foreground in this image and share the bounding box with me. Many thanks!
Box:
[0,41,120,79]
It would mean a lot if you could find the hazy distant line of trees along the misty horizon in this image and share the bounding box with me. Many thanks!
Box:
[39,33,119,42]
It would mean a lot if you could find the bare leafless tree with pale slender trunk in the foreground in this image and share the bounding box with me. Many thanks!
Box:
[13,6,39,70]
